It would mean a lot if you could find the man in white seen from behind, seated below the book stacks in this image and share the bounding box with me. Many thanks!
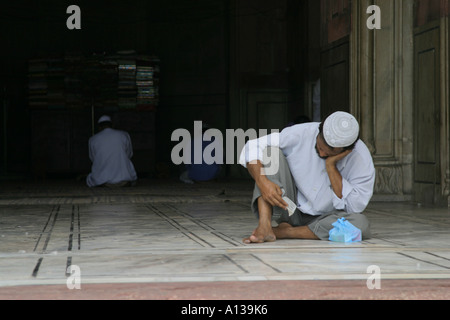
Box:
[86,116,137,187]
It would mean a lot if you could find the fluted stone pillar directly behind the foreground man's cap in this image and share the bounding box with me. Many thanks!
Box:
[351,0,413,201]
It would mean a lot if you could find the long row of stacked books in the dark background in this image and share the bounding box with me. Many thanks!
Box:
[28,52,159,110]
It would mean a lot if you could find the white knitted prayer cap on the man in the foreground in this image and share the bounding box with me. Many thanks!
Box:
[323,111,359,148]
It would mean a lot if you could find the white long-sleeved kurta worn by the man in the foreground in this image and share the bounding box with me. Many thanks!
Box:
[239,122,375,216]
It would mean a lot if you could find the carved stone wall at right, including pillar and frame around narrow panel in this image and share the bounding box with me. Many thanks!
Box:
[350,0,450,206]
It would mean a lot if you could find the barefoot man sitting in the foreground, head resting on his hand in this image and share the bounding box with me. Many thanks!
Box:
[239,112,375,243]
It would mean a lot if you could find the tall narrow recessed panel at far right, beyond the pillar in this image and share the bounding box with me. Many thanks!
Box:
[414,24,440,203]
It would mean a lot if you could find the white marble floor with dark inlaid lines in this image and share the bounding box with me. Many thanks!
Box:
[0,180,450,286]
